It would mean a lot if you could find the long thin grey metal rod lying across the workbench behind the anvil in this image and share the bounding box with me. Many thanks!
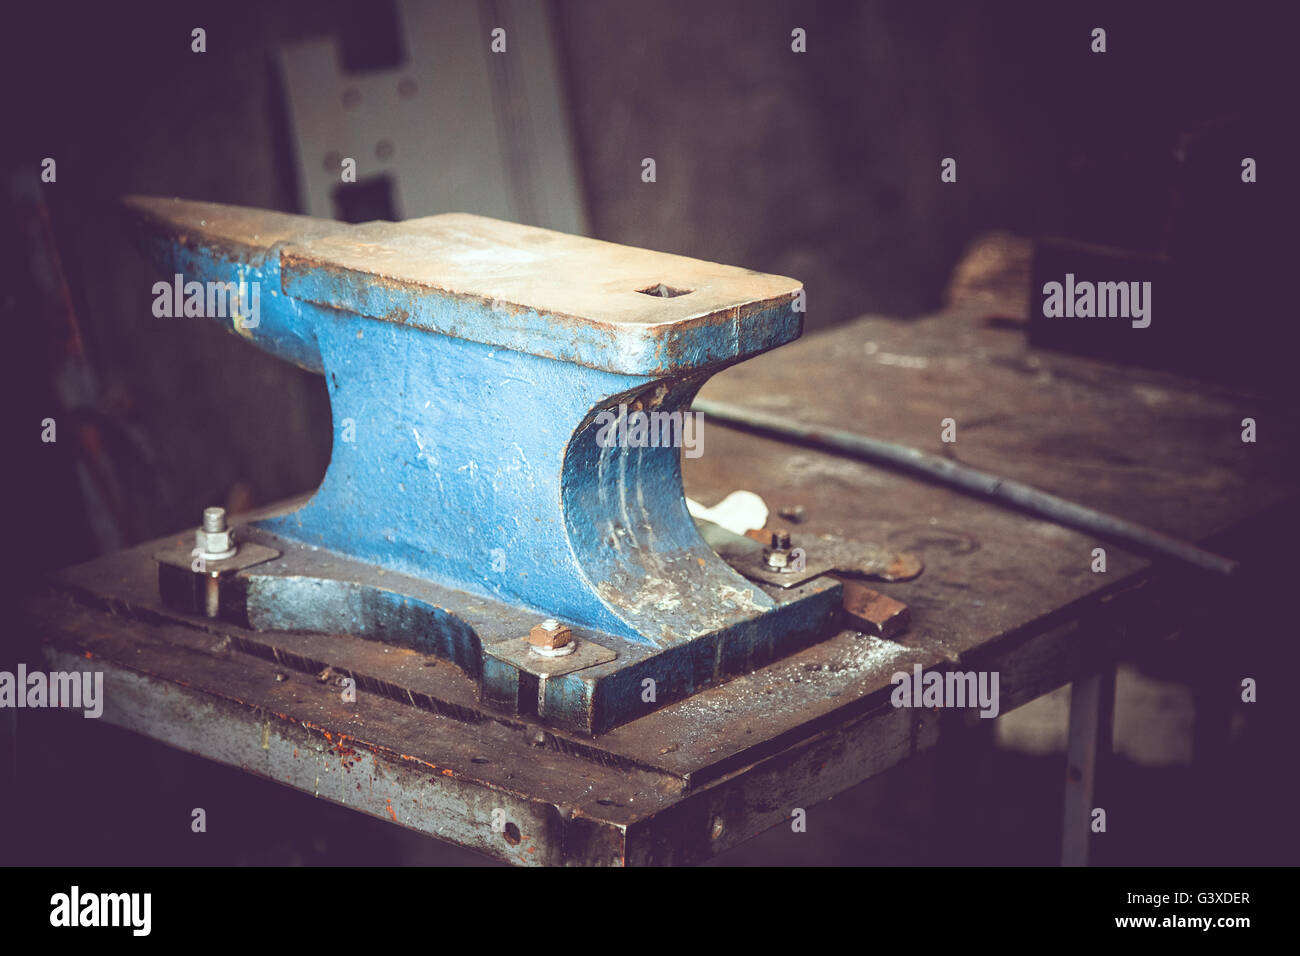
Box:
[692,398,1238,575]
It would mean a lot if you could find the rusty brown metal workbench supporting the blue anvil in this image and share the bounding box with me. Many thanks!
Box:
[29,313,1296,865]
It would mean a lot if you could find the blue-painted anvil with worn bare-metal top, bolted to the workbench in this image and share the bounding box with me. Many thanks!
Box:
[127,199,839,730]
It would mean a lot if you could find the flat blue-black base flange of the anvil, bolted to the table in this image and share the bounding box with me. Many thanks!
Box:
[81,509,841,735]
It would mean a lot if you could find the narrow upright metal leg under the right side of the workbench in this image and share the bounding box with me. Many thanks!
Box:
[1061,663,1115,866]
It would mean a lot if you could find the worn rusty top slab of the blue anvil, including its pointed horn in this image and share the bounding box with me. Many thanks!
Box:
[126,196,801,372]
